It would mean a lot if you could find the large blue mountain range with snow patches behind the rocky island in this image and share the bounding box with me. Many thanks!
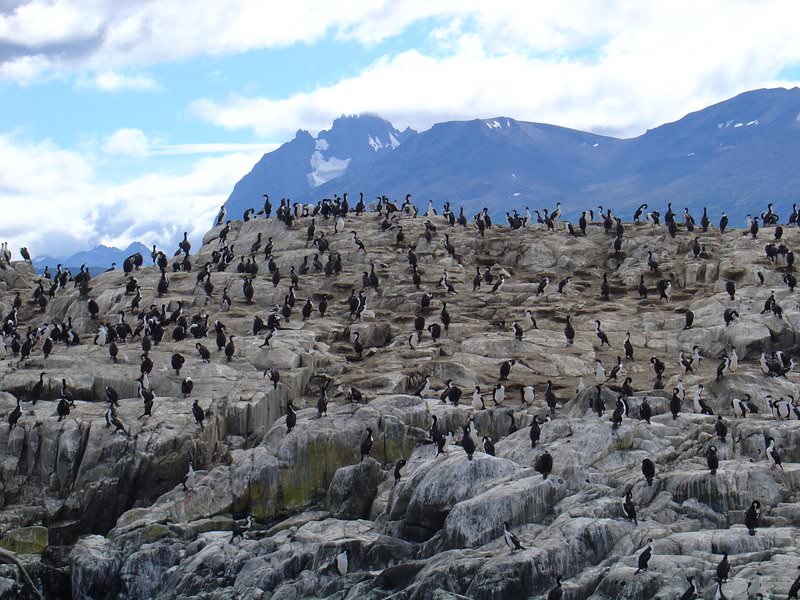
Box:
[226,88,800,223]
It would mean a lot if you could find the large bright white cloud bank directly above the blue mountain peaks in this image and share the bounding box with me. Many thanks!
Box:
[191,0,800,137]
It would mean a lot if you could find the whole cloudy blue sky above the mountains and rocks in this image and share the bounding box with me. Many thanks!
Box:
[0,0,800,258]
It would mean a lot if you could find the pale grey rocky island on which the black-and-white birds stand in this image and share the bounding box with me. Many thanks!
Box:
[0,204,800,599]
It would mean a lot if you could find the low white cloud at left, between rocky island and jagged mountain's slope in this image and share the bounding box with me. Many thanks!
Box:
[0,134,261,255]
